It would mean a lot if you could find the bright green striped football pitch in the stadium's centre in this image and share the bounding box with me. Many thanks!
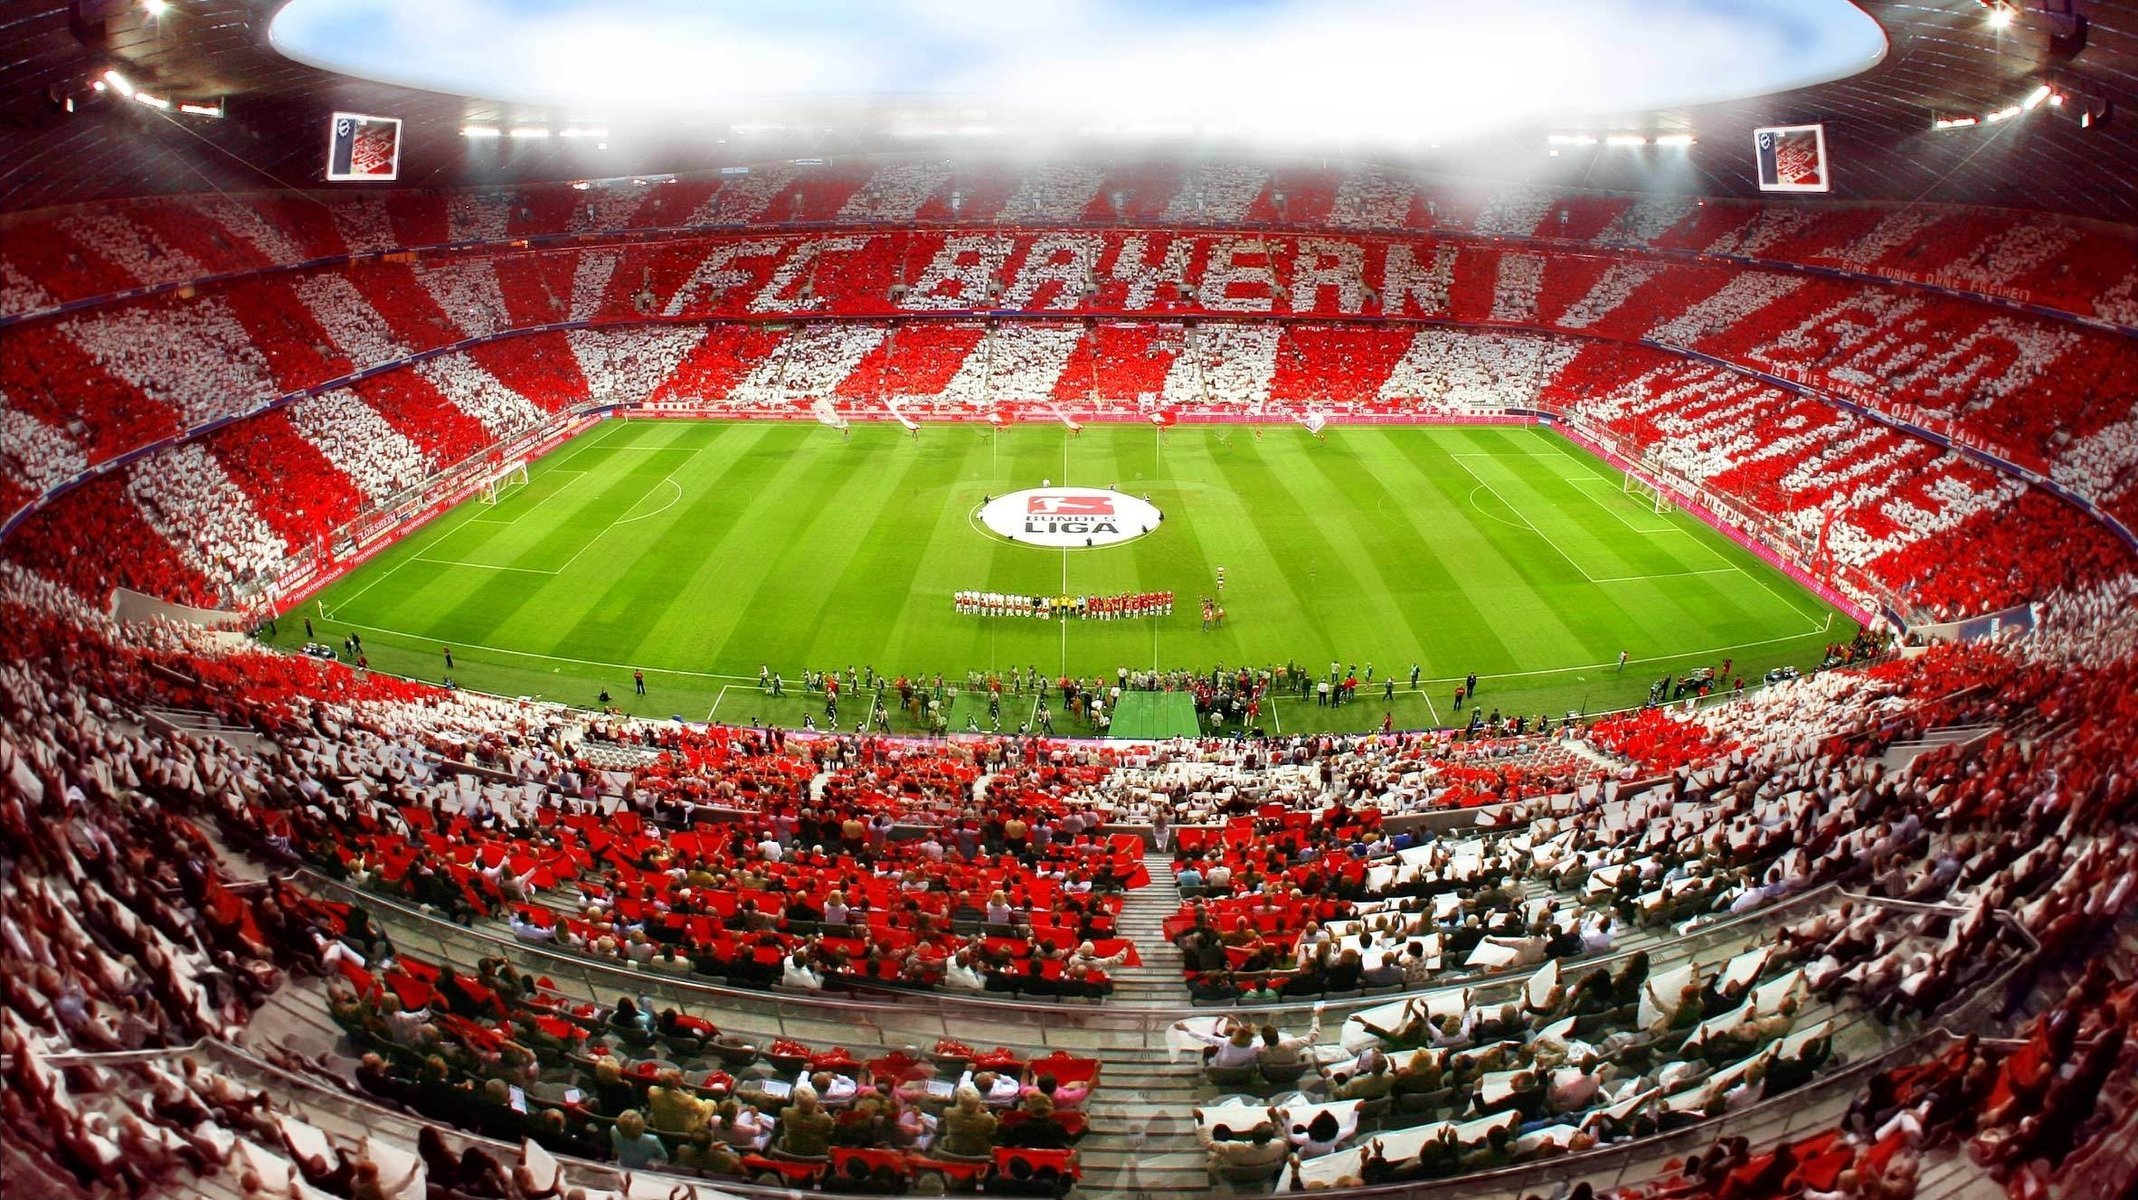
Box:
[274,421,1854,734]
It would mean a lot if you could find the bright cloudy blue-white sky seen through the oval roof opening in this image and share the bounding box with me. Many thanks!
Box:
[272,0,1886,141]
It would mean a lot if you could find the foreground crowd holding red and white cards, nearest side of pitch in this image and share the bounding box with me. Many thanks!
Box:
[4,509,2138,1196]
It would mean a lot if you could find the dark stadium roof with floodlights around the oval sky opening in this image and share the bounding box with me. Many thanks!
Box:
[0,0,2138,222]
